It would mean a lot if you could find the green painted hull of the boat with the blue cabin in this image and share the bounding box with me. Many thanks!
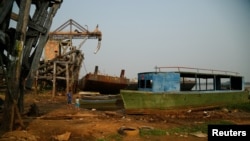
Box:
[120,90,249,109]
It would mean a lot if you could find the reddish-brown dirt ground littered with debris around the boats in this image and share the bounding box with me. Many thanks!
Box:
[0,92,250,141]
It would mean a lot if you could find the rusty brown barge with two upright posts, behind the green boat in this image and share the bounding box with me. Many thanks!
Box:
[78,66,129,94]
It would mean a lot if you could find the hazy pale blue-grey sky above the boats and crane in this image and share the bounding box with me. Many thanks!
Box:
[51,0,250,81]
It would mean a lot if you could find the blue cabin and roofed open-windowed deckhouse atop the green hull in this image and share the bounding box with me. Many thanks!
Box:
[138,67,244,93]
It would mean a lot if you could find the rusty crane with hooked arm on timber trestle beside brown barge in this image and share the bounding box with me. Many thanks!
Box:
[35,19,102,96]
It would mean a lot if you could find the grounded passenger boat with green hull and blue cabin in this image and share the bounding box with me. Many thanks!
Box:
[121,66,249,111]
